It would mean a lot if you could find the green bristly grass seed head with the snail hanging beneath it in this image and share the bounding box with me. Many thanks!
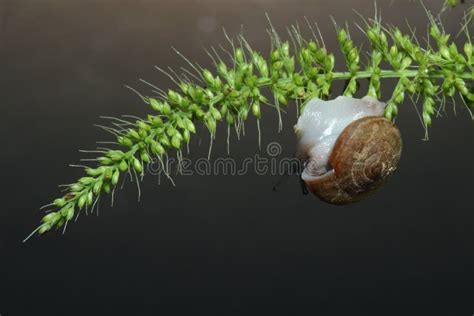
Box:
[26,0,474,239]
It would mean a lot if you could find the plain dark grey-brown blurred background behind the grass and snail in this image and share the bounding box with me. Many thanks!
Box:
[0,0,474,316]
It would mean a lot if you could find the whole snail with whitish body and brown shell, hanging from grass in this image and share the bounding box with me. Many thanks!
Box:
[295,96,402,204]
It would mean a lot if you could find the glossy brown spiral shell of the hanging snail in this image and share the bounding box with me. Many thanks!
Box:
[305,116,402,204]
